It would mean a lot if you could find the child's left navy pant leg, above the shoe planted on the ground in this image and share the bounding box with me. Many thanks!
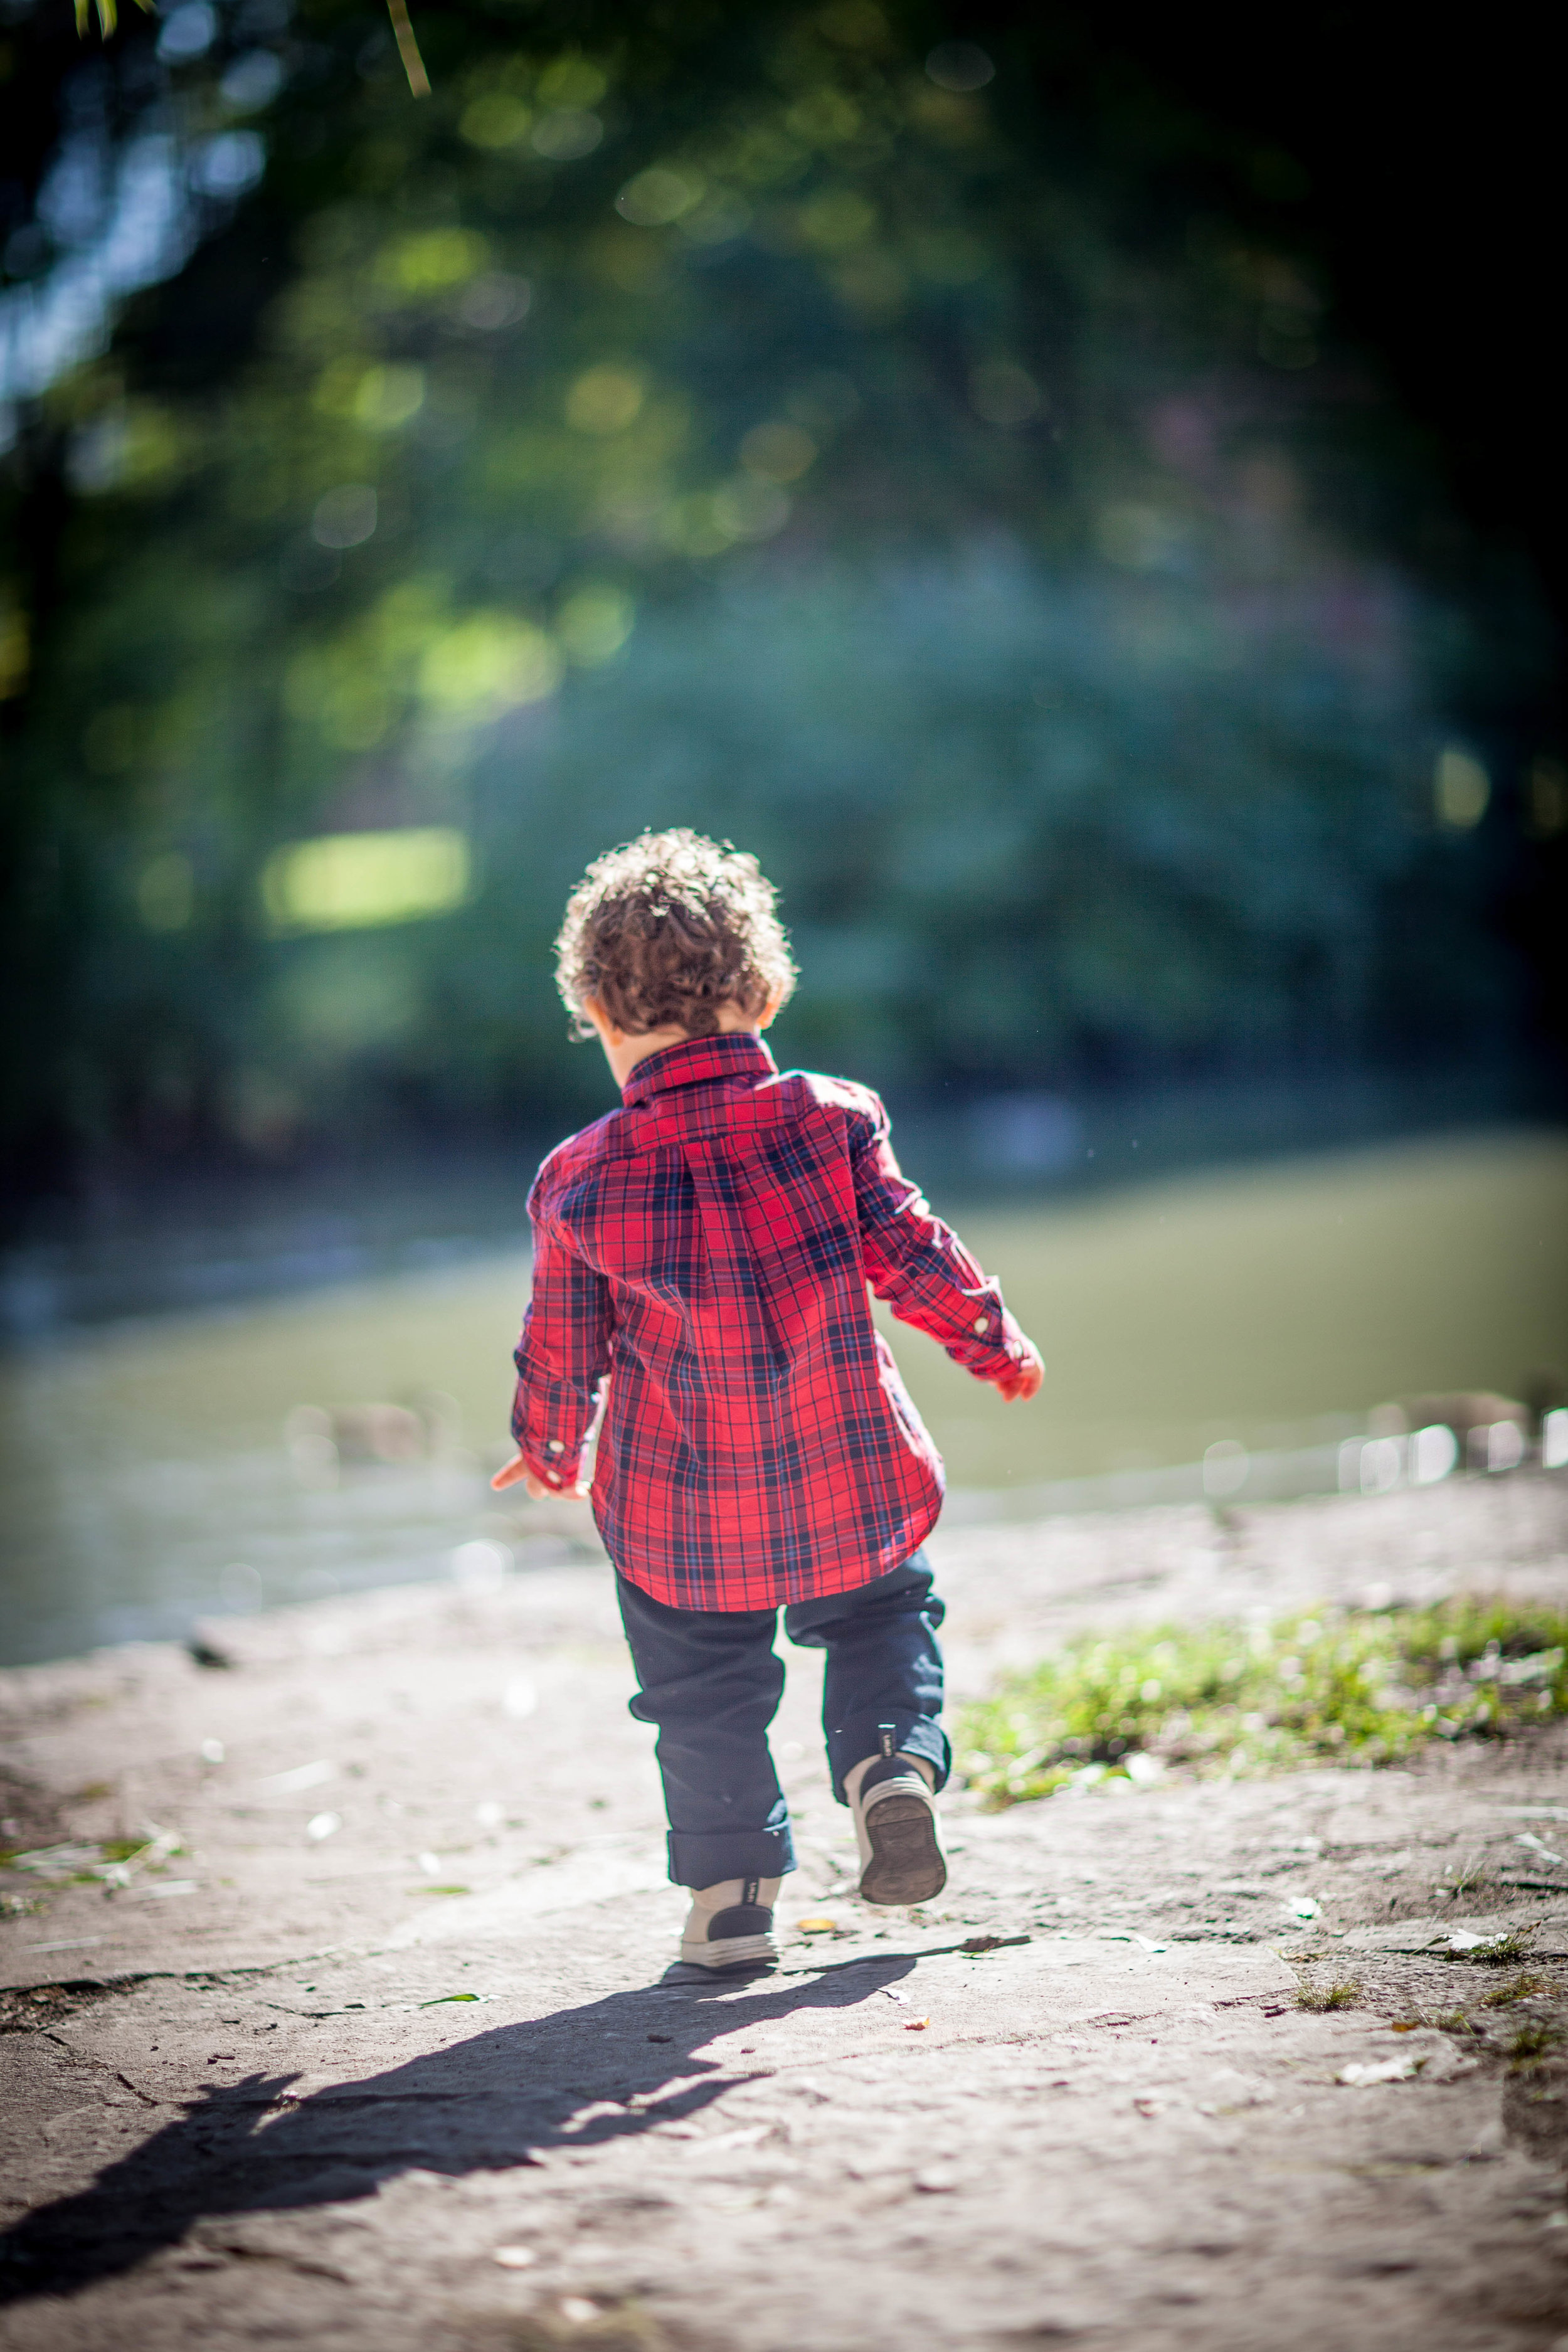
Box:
[616,1576,795,1887]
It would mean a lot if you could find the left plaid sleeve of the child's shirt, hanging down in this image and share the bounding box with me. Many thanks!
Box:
[512,1176,613,1489]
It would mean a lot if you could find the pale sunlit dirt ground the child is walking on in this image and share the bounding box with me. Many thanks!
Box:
[0,1475,1568,2352]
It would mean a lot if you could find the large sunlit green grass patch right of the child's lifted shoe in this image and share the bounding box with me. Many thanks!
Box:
[956,1602,1568,1806]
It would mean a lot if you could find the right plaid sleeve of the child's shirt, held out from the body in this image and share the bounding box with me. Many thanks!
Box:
[851,1096,1027,1380]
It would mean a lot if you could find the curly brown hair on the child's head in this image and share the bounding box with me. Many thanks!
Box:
[555,825,795,1037]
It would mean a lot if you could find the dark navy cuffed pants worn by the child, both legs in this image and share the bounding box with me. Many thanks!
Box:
[616,1552,950,1887]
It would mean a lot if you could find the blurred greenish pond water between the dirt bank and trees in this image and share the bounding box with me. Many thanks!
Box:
[0,1122,1568,1661]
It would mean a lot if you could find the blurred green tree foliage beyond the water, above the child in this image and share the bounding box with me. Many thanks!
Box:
[0,0,1545,1185]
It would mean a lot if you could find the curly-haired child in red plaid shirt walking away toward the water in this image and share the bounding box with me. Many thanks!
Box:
[494,828,1044,1969]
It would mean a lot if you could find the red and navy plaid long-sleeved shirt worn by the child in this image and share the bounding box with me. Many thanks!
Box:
[512,1032,1025,1609]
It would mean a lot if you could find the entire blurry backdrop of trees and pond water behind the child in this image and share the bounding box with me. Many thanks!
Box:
[0,0,1568,1656]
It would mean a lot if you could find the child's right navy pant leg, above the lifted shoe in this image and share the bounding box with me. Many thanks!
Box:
[785,1552,952,1804]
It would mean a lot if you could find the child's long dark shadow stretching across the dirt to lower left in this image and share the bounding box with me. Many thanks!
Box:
[0,1954,914,2302]
